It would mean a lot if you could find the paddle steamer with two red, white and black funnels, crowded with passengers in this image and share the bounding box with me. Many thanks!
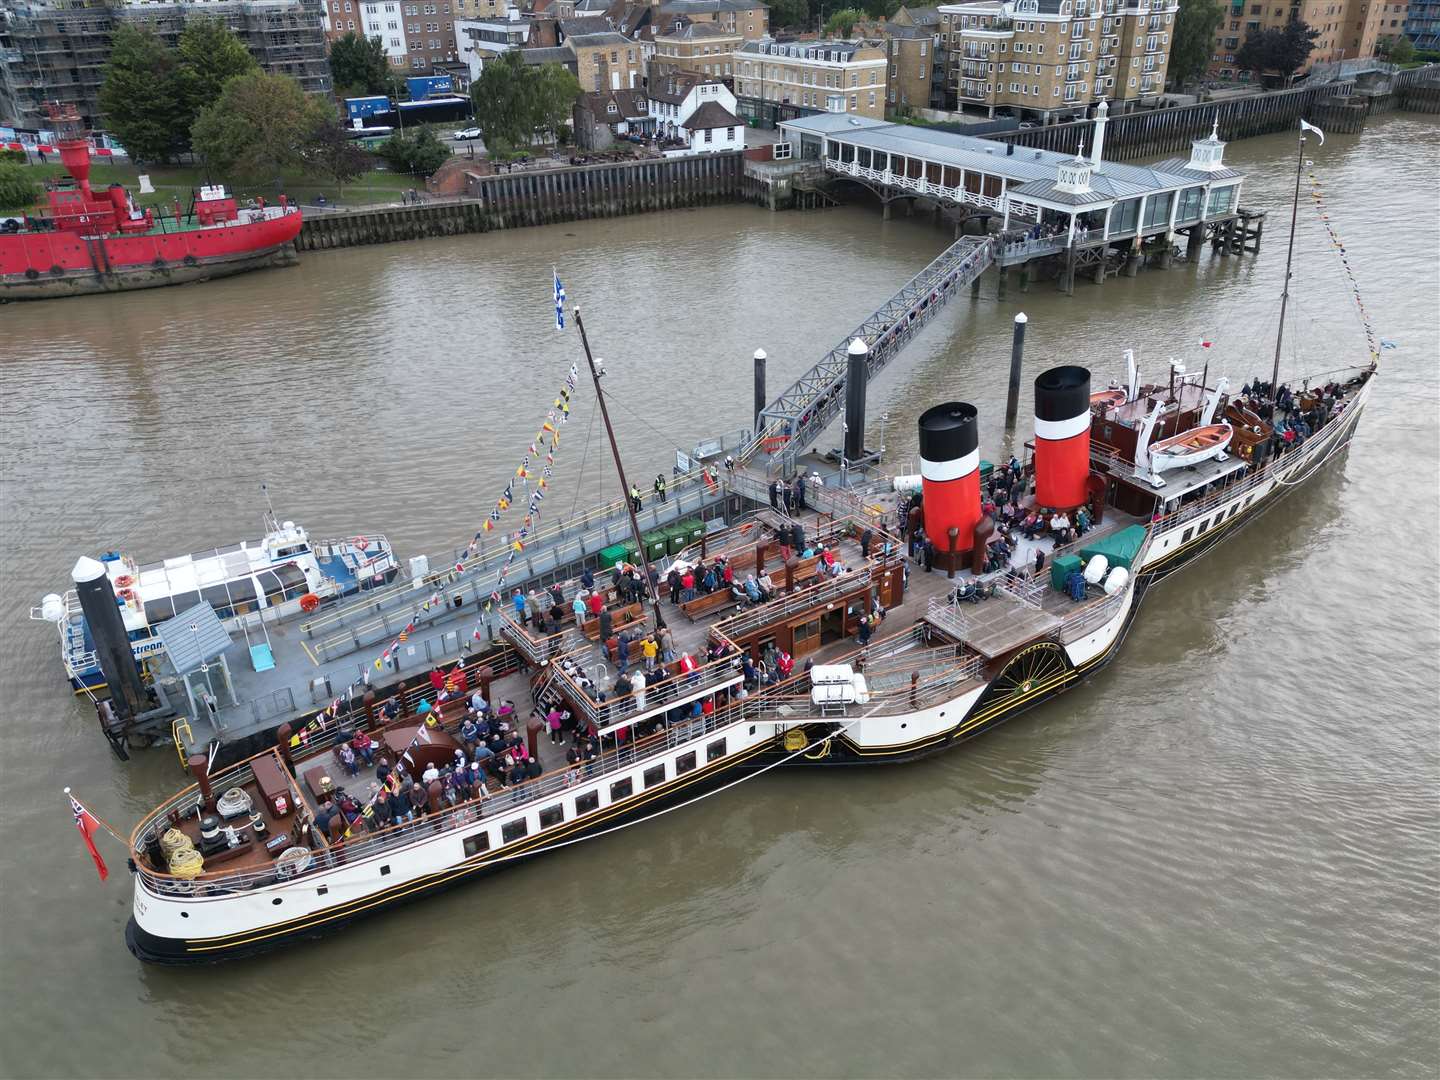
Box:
[115,120,1375,963]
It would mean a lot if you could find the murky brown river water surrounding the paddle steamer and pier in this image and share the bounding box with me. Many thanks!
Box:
[0,114,1440,1077]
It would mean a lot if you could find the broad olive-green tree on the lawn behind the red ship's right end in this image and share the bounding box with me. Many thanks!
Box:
[190,72,330,180]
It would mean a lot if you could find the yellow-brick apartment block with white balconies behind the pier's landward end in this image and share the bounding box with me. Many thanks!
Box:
[940,0,1179,124]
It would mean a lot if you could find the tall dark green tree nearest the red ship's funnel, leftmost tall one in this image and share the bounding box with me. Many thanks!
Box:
[99,24,187,161]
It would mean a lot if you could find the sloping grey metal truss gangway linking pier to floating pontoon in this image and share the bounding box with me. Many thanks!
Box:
[740,236,995,472]
